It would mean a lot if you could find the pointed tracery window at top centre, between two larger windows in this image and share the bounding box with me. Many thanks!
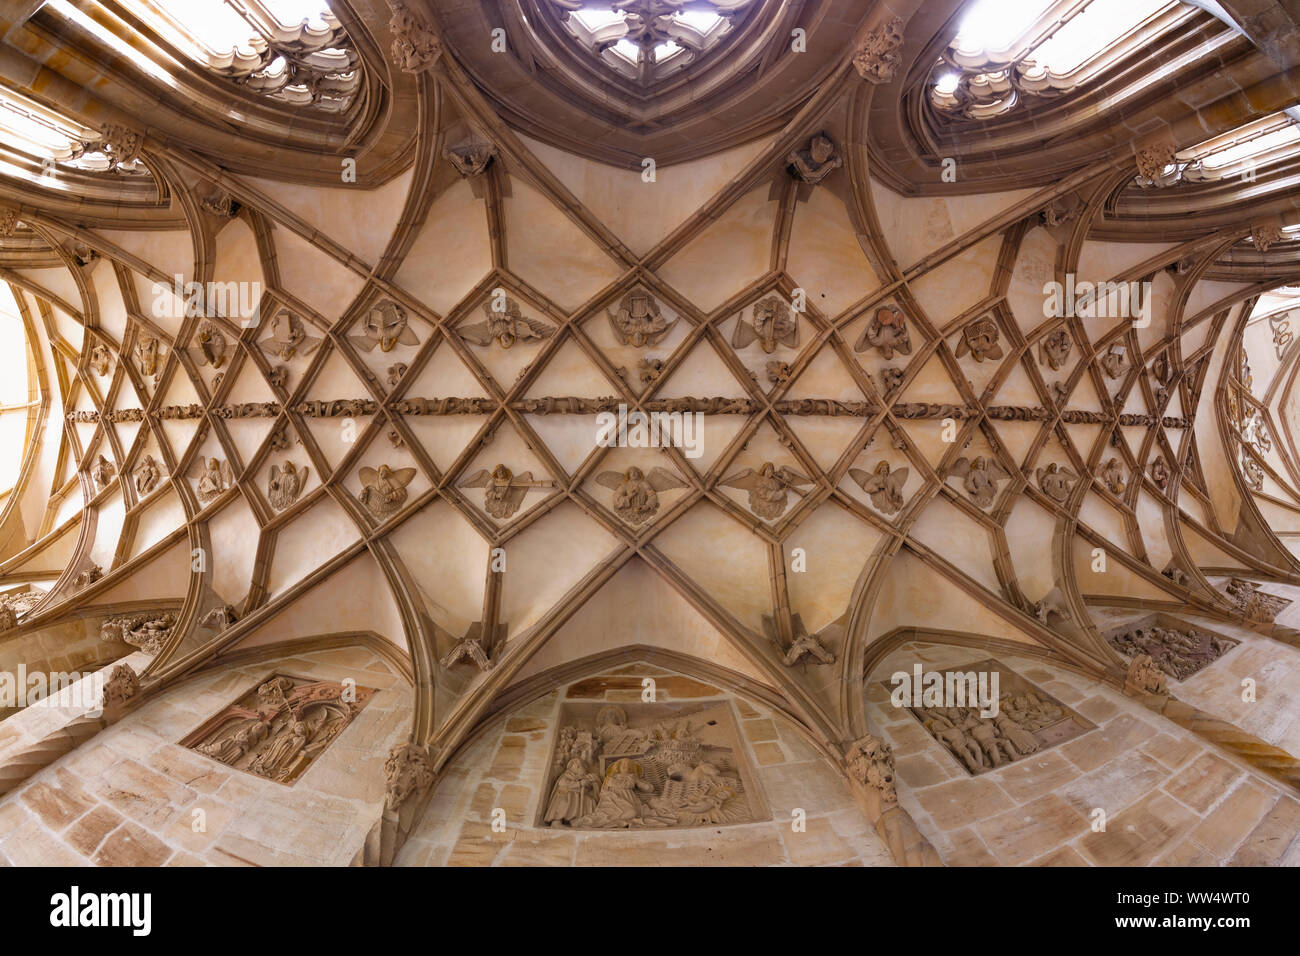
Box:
[549,0,758,83]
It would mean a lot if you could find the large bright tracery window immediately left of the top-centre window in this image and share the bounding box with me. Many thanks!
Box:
[49,0,361,112]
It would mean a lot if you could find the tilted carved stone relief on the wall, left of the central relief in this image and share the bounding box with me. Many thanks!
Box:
[181,674,374,784]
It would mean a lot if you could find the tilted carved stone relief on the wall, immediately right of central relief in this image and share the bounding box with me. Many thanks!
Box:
[881,658,1096,775]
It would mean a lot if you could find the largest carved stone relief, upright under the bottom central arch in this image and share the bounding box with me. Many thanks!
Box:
[537,701,770,830]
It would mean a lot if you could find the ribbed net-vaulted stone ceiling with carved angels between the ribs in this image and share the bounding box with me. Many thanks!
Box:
[0,0,1300,780]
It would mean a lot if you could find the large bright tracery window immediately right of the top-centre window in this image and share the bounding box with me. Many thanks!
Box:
[931,0,1196,120]
